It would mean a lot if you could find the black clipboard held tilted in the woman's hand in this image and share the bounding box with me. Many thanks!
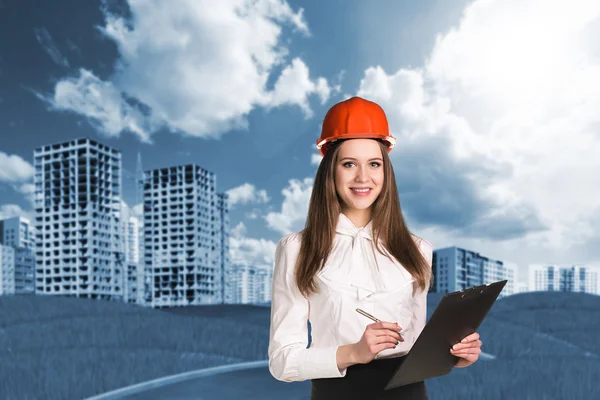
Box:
[385,280,508,390]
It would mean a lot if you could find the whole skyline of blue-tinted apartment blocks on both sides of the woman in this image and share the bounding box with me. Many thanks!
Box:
[0,142,600,307]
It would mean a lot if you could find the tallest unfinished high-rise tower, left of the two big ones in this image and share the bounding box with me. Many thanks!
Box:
[34,138,125,300]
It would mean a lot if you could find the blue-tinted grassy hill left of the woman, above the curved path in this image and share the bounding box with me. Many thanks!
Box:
[0,296,269,399]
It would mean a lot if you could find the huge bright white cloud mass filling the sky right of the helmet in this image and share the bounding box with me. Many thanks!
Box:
[357,0,600,262]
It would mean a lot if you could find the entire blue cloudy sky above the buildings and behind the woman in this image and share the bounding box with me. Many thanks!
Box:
[0,0,600,282]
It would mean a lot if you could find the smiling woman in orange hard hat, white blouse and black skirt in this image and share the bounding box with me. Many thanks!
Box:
[268,97,481,400]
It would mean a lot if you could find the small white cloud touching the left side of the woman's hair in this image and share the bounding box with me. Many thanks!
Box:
[265,178,313,235]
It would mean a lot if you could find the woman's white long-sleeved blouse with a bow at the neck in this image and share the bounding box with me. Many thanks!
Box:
[268,213,433,382]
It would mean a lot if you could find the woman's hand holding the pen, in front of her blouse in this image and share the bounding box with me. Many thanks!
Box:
[354,321,404,364]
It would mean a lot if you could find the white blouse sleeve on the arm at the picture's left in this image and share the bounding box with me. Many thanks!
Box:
[268,234,346,382]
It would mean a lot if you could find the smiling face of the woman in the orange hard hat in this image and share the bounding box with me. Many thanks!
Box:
[335,139,384,219]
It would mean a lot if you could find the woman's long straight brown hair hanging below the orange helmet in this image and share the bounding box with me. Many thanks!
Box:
[295,140,432,297]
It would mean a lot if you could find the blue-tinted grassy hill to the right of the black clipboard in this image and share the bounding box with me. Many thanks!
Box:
[427,292,600,400]
